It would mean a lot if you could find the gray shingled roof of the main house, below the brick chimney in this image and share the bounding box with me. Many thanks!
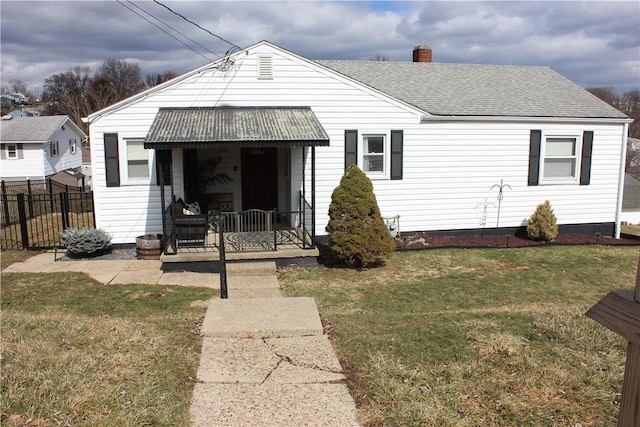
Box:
[315,60,626,118]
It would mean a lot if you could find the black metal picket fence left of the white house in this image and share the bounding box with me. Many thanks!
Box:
[0,191,95,250]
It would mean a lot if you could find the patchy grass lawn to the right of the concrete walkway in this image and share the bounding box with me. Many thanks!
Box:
[281,246,639,426]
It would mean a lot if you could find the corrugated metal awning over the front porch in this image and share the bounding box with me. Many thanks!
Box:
[144,107,329,150]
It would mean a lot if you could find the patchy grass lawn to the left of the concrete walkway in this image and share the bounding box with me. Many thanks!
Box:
[0,270,213,426]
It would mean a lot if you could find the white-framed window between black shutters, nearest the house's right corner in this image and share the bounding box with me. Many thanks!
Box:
[542,135,580,183]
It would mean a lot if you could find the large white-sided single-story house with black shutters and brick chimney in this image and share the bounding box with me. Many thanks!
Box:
[84,41,630,251]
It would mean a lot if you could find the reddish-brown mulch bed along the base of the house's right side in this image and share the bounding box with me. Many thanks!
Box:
[395,232,640,250]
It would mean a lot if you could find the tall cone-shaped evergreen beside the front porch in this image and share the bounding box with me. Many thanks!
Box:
[326,165,395,267]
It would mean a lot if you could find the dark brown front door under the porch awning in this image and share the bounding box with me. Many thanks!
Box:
[242,148,278,210]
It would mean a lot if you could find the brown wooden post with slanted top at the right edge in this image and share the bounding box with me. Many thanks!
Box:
[587,254,640,427]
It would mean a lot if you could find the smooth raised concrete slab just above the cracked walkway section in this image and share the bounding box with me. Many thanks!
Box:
[202,297,322,338]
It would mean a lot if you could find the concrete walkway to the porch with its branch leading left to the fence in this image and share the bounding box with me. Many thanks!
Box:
[3,253,359,427]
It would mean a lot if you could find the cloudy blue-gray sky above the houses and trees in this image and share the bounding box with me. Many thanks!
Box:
[0,0,640,94]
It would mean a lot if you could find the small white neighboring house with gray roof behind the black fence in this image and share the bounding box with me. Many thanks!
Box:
[0,116,87,181]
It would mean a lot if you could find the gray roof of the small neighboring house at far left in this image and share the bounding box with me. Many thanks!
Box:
[0,116,69,142]
